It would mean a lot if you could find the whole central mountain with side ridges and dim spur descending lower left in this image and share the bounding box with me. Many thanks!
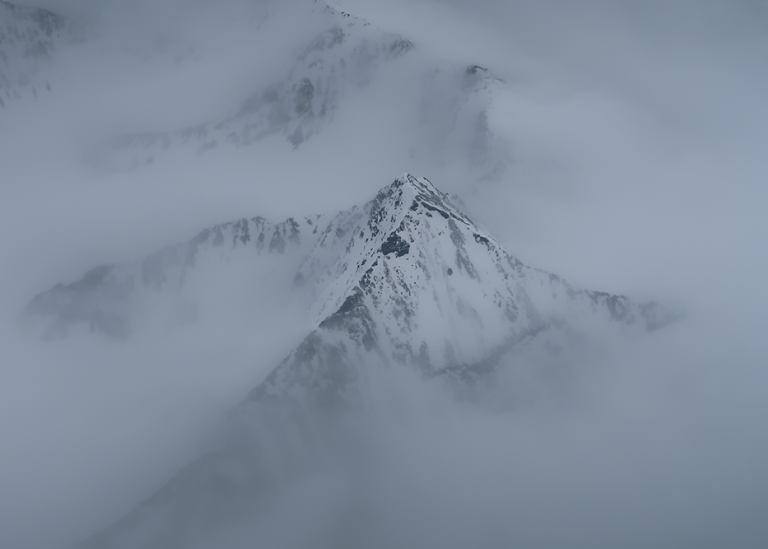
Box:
[27,175,668,548]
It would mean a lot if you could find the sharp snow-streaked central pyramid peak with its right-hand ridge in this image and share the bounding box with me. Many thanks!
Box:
[252,175,669,400]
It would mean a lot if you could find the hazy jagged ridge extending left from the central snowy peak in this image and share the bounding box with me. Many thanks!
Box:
[24,216,322,339]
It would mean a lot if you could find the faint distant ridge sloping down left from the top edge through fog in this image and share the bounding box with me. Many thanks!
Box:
[94,4,413,171]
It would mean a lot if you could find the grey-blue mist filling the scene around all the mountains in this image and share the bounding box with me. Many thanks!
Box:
[0,0,768,549]
